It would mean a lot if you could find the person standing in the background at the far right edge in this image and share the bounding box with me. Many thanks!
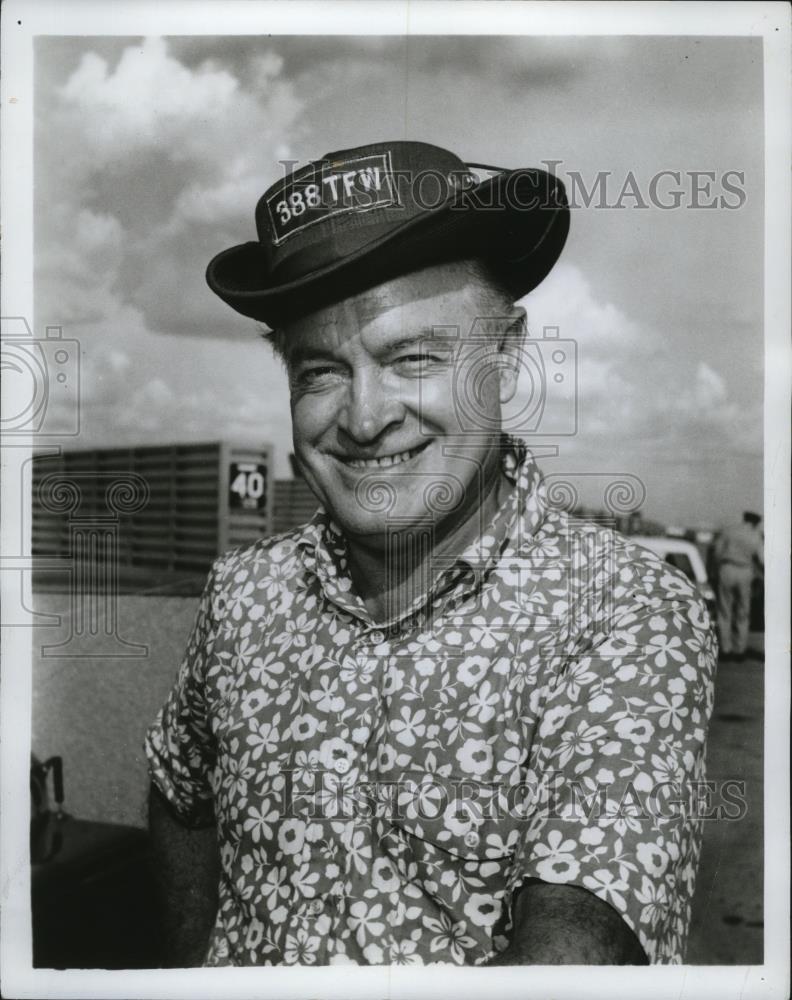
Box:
[714,510,764,662]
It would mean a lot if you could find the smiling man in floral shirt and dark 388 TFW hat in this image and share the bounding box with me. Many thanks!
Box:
[147,142,714,965]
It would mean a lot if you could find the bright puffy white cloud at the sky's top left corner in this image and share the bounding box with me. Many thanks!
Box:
[50,38,302,191]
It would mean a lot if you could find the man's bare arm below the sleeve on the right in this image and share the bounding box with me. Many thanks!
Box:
[487,879,648,965]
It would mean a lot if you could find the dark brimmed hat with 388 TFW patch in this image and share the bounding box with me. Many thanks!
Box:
[206,141,569,328]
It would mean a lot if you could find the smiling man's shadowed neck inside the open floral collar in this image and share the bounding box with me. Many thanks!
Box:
[347,471,514,622]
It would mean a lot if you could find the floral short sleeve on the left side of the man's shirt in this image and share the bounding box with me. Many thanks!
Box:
[144,569,217,827]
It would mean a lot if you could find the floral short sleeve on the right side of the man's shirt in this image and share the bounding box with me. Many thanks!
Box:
[508,588,717,963]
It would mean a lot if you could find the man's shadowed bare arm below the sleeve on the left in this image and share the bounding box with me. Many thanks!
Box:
[149,784,219,968]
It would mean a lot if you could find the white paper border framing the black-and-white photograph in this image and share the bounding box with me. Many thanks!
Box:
[0,0,792,1000]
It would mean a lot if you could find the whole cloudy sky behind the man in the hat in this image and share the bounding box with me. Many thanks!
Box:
[34,36,763,525]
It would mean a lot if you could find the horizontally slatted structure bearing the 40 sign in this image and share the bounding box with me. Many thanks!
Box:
[31,441,276,593]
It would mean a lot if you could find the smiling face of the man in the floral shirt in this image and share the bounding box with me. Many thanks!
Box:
[283,264,520,546]
